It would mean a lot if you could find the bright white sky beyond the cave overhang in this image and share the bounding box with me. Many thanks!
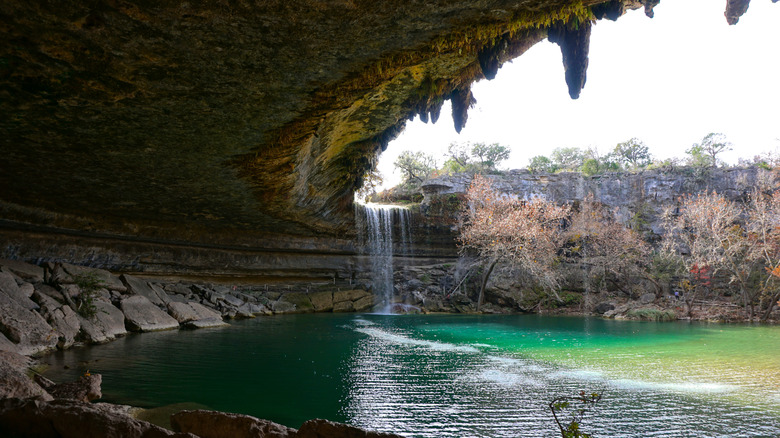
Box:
[379,0,780,187]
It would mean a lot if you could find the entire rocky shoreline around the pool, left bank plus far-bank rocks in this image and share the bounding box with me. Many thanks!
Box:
[0,260,772,438]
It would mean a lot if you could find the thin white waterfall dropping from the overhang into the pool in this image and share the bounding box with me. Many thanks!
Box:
[357,204,412,313]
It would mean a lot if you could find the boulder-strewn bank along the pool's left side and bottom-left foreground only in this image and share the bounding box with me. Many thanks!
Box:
[0,260,397,438]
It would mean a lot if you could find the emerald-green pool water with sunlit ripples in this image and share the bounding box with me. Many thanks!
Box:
[41,314,780,437]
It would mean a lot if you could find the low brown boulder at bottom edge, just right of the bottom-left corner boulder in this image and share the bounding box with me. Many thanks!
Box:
[171,410,296,438]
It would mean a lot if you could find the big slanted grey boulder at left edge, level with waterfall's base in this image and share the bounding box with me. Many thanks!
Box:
[0,293,57,355]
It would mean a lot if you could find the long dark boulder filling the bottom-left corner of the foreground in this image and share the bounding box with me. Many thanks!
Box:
[0,398,197,438]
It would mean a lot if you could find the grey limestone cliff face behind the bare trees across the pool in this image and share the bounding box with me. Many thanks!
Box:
[421,167,772,240]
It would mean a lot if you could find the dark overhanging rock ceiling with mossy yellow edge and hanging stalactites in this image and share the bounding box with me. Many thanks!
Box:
[0,0,776,242]
